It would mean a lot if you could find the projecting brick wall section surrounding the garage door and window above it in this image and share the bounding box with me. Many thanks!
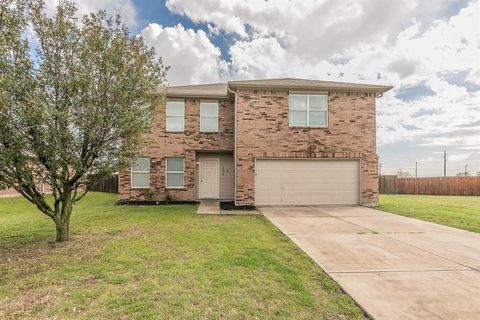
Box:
[236,90,378,205]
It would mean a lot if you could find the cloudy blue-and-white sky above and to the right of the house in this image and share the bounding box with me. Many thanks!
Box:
[47,0,480,176]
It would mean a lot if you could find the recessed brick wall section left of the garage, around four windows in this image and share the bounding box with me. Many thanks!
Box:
[119,99,234,201]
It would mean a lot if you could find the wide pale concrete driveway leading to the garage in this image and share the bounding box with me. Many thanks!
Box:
[260,207,480,320]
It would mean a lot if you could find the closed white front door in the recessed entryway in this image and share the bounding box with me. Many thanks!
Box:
[198,159,219,199]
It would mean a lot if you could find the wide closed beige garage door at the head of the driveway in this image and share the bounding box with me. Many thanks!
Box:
[255,159,360,205]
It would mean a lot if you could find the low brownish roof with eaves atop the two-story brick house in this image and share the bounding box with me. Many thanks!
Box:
[160,78,393,98]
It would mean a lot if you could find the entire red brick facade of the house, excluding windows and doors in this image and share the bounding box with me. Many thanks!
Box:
[119,90,378,205]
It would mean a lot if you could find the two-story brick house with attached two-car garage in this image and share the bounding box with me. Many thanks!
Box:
[119,78,391,205]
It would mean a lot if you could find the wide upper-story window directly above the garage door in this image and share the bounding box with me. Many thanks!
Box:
[288,93,328,127]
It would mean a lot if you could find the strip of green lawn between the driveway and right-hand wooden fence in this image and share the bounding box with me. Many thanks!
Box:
[378,194,480,233]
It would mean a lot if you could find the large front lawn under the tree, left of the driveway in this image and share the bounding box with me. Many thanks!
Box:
[0,193,365,319]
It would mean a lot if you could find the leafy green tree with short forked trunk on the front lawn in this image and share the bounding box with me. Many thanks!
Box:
[0,0,168,242]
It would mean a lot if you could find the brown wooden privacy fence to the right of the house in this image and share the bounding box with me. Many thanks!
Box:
[380,176,480,196]
